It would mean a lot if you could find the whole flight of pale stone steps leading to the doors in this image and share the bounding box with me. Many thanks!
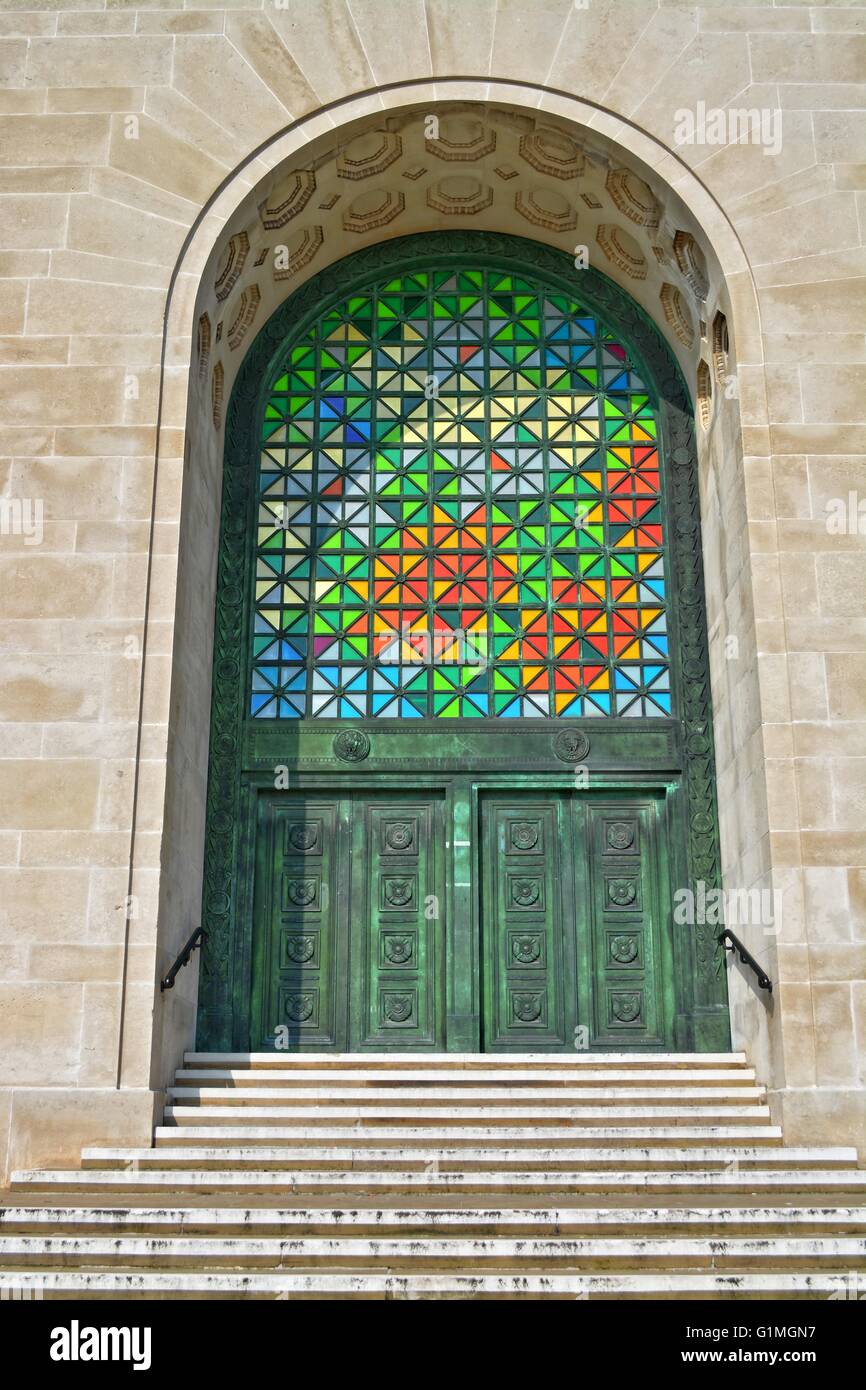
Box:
[0,1052,866,1300]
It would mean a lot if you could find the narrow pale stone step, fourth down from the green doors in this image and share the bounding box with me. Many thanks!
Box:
[164,1097,770,1127]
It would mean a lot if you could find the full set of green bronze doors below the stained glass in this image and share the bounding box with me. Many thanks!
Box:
[250,780,674,1052]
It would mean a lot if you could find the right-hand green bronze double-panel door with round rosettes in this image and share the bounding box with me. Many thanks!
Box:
[480,791,673,1052]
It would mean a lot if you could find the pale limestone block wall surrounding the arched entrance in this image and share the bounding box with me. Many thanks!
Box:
[0,0,866,1169]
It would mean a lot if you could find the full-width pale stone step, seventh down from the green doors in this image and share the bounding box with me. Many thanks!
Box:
[10,1168,866,1201]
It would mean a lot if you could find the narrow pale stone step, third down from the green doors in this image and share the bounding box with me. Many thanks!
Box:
[165,1084,766,1109]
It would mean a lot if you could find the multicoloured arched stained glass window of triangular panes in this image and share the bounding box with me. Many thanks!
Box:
[249,267,671,720]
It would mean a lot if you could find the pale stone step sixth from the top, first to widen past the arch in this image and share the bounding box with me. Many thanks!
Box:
[82,1143,858,1172]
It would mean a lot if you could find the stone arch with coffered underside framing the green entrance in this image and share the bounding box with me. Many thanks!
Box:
[132,81,771,1084]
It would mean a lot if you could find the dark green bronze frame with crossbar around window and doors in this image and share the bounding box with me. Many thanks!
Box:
[197,232,730,1051]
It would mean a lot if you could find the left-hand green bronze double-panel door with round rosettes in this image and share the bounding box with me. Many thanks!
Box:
[250,792,445,1052]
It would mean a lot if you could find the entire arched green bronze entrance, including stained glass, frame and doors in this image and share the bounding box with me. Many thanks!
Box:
[199,234,728,1052]
